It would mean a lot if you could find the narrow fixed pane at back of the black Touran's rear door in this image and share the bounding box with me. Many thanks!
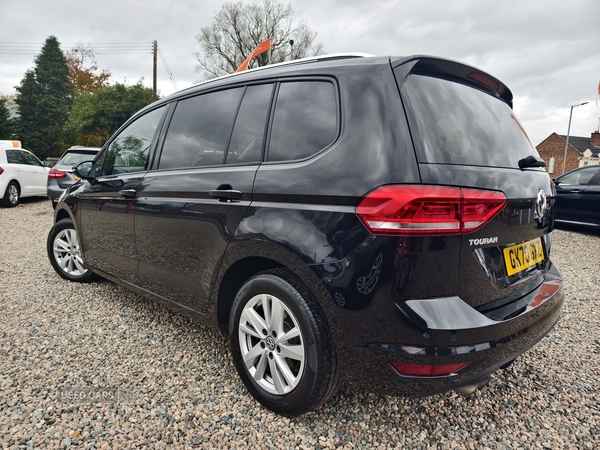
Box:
[225,84,273,164]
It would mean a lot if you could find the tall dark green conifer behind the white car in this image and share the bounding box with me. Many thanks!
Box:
[15,36,72,158]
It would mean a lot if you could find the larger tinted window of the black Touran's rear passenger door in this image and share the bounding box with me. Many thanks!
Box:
[158,88,244,169]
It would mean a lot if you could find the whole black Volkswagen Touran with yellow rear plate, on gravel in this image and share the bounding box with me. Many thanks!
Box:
[48,55,564,415]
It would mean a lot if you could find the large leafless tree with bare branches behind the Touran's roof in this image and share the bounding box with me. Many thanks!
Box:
[194,0,323,78]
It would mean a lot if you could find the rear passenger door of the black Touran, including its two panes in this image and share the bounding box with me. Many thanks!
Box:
[135,84,273,312]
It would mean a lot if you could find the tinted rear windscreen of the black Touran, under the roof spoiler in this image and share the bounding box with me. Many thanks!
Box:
[401,74,538,168]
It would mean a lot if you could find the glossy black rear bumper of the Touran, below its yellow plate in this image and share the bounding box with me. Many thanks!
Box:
[324,263,564,397]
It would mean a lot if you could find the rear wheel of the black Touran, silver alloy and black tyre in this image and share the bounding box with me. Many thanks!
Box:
[229,270,339,416]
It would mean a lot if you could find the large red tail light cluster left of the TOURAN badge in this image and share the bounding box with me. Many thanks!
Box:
[356,185,506,236]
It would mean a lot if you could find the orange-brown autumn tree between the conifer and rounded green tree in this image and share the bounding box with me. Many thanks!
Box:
[66,43,111,98]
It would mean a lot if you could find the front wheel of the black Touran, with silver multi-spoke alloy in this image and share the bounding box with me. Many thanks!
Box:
[46,219,98,283]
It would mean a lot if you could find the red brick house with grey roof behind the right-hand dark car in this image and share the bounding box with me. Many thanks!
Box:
[536,131,600,177]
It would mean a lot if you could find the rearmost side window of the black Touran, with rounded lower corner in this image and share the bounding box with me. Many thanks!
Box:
[267,81,338,161]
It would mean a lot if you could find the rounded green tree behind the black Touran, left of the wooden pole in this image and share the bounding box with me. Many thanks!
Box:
[66,80,152,147]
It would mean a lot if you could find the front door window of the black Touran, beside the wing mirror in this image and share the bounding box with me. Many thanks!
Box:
[100,106,165,176]
